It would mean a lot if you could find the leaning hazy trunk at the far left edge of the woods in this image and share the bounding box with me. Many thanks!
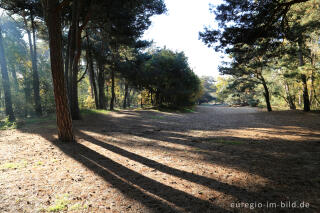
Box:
[0,26,15,121]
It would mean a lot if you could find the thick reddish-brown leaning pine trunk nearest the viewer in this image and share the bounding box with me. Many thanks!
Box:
[42,0,74,142]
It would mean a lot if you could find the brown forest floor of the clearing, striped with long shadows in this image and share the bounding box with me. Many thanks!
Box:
[0,106,320,213]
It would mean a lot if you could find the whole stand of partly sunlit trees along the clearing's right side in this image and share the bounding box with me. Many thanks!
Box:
[200,0,320,111]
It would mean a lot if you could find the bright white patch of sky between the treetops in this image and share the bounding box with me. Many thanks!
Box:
[143,0,222,77]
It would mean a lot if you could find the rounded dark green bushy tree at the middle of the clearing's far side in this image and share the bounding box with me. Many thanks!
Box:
[140,49,201,106]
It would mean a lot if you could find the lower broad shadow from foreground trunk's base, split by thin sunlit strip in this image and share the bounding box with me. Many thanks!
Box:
[47,135,229,212]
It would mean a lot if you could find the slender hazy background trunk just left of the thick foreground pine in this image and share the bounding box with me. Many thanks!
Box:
[31,13,42,116]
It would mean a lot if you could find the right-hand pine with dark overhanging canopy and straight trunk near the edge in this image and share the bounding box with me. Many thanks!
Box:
[200,0,319,111]
